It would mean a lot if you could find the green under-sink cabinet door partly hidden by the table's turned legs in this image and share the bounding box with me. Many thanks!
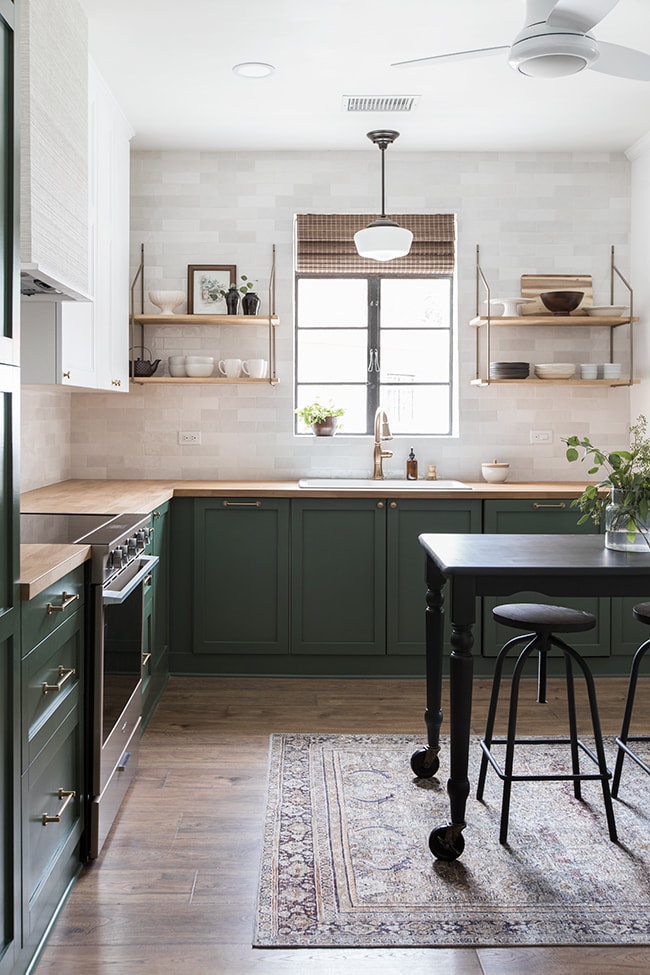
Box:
[386,499,482,654]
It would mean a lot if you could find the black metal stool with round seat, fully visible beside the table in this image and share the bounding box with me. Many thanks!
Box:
[476,603,616,843]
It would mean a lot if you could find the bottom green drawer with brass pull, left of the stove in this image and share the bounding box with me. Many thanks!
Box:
[23,707,84,942]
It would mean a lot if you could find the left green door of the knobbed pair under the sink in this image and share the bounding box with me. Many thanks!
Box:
[291,498,386,655]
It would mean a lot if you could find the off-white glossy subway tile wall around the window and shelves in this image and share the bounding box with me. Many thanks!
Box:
[23,150,631,489]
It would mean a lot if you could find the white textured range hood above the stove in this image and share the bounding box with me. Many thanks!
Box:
[20,0,89,298]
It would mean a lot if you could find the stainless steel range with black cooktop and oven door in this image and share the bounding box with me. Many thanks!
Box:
[20,513,158,858]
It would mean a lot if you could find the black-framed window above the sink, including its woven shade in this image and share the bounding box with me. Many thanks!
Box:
[295,215,454,436]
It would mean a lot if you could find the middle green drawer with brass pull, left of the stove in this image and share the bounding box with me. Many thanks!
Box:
[22,613,84,768]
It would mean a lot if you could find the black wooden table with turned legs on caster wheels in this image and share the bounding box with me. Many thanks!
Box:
[411,534,650,860]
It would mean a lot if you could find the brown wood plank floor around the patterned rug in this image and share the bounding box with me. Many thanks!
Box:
[36,677,650,975]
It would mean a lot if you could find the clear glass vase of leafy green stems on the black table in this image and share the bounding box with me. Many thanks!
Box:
[562,416,650,552]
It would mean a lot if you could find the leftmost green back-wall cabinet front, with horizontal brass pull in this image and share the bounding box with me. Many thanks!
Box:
[192,498,289,656]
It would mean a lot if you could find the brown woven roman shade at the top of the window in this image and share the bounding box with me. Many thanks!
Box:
[296,213,456,277]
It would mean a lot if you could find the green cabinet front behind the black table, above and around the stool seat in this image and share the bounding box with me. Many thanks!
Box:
[483,498,611,657]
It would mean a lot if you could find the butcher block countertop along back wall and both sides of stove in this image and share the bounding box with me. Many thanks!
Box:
[20,479,584,599]
